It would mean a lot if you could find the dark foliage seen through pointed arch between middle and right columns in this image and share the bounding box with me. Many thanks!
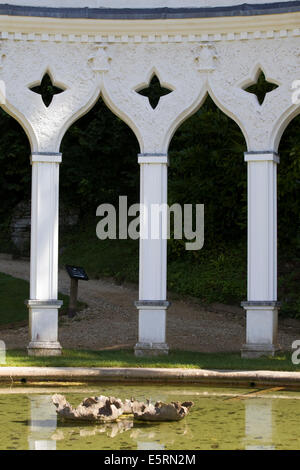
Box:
[168,96,247,350]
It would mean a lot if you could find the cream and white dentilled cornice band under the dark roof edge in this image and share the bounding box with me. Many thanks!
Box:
[0,8,300,45]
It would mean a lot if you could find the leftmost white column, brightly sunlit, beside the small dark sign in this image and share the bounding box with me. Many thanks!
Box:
[27,153,62,356]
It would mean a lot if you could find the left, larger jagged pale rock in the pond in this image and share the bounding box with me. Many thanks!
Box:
[52,395,123,422]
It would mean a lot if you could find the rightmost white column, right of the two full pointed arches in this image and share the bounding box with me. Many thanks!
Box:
[242,152,279,357]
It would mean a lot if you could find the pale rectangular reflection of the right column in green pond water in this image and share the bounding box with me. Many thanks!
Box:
[244,398,274,450]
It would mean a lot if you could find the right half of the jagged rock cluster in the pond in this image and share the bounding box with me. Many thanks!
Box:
[133,401,194,421]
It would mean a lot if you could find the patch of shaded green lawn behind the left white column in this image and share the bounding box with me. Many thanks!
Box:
[0,273,84,325]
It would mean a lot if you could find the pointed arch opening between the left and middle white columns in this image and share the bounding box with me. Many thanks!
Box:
[59,97,139,349]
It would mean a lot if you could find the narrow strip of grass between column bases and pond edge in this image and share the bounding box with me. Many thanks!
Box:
[3,350,300,371]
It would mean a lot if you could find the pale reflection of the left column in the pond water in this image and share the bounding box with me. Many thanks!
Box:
[28,395,57,450]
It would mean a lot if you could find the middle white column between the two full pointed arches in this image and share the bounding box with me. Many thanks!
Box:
[135,154,169,356]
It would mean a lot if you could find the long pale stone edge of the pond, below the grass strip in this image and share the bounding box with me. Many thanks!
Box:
[0,367,300,389]
